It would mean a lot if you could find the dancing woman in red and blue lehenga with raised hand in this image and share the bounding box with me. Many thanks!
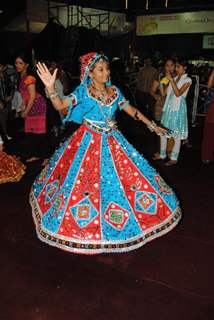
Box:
[30,52,181,254]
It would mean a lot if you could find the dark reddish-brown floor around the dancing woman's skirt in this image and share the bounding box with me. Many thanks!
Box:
[0,120,214,320]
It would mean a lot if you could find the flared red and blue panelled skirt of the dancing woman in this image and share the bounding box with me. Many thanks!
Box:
[30,124,181,254]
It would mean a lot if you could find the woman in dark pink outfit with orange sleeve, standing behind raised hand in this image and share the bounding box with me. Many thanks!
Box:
[15,53,49,162]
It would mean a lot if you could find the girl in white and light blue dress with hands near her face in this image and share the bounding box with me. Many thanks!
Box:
[153,58,192,166]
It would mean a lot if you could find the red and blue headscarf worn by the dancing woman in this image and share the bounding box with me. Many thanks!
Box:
[79,52,111,85]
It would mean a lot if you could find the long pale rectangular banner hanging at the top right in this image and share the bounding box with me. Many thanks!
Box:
[136,11,214,36]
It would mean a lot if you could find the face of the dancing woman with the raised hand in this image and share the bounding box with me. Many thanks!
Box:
[89,60,110,84]
